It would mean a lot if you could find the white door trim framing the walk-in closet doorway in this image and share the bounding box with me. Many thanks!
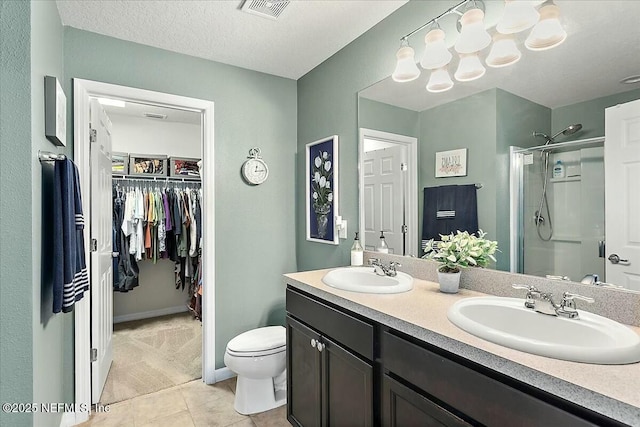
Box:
[73,79,216,423]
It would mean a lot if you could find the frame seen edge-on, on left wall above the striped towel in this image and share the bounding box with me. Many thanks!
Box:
[44,76,67,147]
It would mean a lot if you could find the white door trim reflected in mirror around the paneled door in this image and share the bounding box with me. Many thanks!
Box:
[358,128,420,256]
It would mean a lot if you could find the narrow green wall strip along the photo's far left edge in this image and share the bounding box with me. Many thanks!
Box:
[0,1,36,426]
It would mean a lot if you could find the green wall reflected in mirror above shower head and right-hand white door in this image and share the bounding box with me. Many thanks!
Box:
[551,89,640,141]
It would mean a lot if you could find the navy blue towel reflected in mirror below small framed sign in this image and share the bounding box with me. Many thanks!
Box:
[422,184,478,249]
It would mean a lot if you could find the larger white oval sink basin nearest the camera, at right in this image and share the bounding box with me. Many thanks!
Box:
[447,297,640,365]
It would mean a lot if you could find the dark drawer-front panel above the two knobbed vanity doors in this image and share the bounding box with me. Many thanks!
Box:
[287,288,373,360]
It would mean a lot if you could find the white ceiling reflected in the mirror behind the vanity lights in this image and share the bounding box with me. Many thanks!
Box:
[360,0,640,111]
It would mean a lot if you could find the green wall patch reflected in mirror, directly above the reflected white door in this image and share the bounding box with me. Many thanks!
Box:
[358,97,420,138]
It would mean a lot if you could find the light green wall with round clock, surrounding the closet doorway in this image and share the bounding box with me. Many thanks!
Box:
[64,27,298,367]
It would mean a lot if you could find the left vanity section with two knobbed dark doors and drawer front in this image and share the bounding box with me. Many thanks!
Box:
[287,290,374,427]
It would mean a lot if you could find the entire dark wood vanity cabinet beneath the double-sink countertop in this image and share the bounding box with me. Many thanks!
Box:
[287,287,624,427]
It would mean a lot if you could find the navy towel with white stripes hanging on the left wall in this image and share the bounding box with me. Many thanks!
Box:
[52,159,89,313]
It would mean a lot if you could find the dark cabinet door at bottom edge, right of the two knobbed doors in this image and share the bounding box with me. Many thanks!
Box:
[382,375,471,427]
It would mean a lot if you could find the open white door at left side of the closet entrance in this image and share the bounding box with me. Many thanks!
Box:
[89,99,113,403]
